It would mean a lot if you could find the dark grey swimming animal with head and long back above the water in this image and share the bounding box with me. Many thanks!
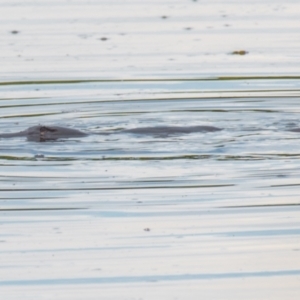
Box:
[0,125,222,142]
